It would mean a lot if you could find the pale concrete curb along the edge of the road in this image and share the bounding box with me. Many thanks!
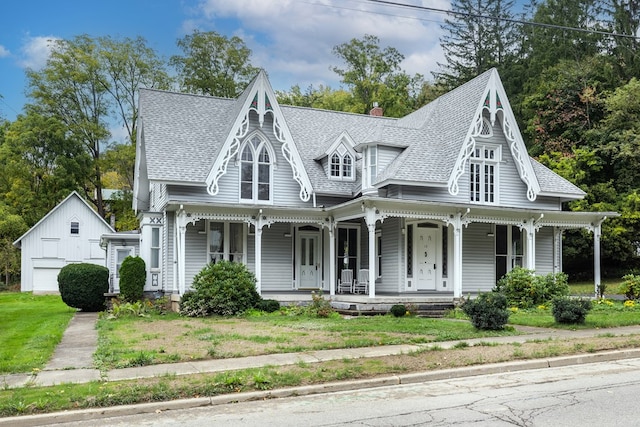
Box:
[5,349,640,427]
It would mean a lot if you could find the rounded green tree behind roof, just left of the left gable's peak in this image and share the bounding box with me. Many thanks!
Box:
[169,30,258,98]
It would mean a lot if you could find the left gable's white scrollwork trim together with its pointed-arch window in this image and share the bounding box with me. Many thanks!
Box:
[206,70,313,203]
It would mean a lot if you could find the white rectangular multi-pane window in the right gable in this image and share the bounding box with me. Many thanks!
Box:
[469,143,500,204]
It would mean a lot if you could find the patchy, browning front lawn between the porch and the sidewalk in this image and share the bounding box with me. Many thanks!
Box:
[95,310,517,369]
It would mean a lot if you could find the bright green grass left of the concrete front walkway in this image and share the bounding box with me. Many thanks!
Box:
[0,292,76,374]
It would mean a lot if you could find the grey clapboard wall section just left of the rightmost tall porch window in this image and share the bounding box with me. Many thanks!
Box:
[462,224,496,292]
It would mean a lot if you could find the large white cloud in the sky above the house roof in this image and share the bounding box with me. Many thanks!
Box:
[183,0,449,90]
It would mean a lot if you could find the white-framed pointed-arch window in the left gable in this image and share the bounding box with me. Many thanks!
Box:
[240,135,274,203]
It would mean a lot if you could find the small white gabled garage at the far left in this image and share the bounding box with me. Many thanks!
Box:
[13,191,115,293]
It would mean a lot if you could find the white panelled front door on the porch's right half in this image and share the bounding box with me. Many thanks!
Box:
[414,224,439,291]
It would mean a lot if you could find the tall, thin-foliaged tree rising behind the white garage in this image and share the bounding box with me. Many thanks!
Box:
[27,35,170,217]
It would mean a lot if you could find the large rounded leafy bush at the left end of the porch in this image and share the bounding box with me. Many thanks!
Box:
[180,261,261,316]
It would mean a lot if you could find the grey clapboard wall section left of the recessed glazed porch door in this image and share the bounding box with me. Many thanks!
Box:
[262,223,294,291]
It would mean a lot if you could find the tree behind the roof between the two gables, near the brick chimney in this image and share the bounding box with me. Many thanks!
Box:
[331,34,423,116]
